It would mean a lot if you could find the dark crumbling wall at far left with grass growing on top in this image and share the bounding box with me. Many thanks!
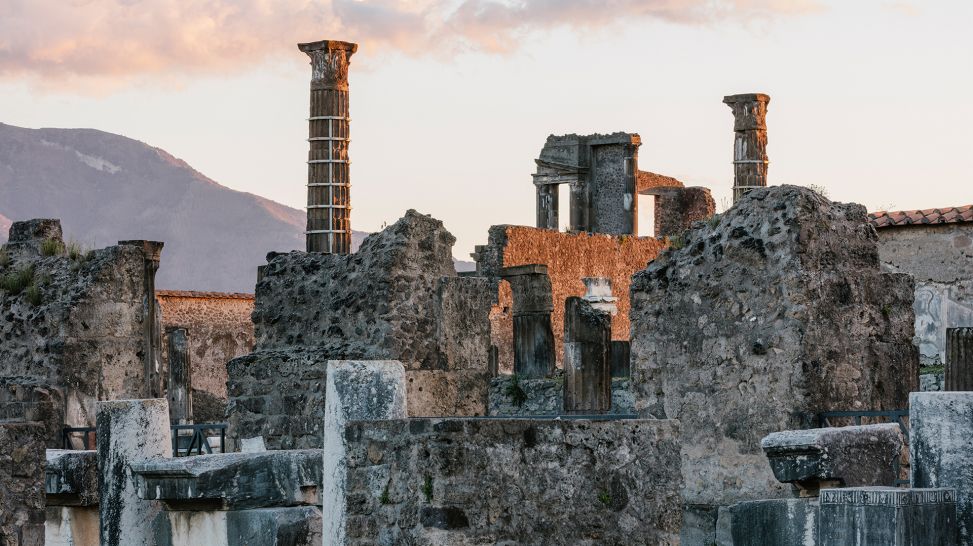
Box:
[0,220,148,434]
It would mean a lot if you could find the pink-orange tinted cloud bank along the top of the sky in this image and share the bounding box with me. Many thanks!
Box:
[0,0,817,82]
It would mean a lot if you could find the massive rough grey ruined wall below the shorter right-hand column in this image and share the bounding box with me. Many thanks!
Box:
[631,186,918,505]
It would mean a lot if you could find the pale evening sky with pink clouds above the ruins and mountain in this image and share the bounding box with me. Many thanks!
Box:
[0,0,973,259]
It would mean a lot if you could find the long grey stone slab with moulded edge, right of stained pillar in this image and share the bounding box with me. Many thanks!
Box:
[131,449,322,510]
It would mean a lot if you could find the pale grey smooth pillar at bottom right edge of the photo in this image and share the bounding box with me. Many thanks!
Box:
[909,392,973,546]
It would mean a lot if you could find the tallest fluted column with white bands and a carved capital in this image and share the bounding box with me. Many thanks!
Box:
[297,40,358,254]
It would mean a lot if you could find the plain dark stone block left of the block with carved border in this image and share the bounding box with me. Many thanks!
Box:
[716,499,819,546]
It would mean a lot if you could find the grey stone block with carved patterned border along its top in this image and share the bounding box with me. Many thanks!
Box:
[819,487,957,546]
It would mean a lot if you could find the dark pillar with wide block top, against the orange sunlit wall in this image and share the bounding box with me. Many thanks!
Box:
[500,264,556,379]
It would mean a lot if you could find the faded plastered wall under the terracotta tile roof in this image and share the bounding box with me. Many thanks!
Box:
[878,222,973,366]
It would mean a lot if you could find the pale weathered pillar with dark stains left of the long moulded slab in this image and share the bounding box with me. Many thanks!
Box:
[97,398,172,546]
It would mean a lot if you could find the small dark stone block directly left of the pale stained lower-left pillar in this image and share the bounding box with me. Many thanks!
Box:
[44,449,98,506]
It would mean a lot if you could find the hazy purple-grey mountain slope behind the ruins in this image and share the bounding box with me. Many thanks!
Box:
[0,123,366,292]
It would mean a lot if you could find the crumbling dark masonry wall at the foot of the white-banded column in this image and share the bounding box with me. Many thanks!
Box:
[227,210,497,449]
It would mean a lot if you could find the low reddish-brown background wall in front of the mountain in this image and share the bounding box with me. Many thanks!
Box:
[155,290,254,423]
